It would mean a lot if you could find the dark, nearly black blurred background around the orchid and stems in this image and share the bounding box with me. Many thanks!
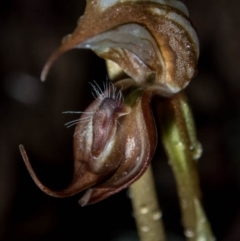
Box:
[0,0,240,241]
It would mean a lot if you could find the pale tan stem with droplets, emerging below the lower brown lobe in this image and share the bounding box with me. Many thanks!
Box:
[130,166,166,241]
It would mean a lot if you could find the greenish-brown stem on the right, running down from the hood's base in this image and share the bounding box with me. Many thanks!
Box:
[157,92,215,241]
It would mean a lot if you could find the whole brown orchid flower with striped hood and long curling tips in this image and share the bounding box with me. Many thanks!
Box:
[20,0,199,205]
